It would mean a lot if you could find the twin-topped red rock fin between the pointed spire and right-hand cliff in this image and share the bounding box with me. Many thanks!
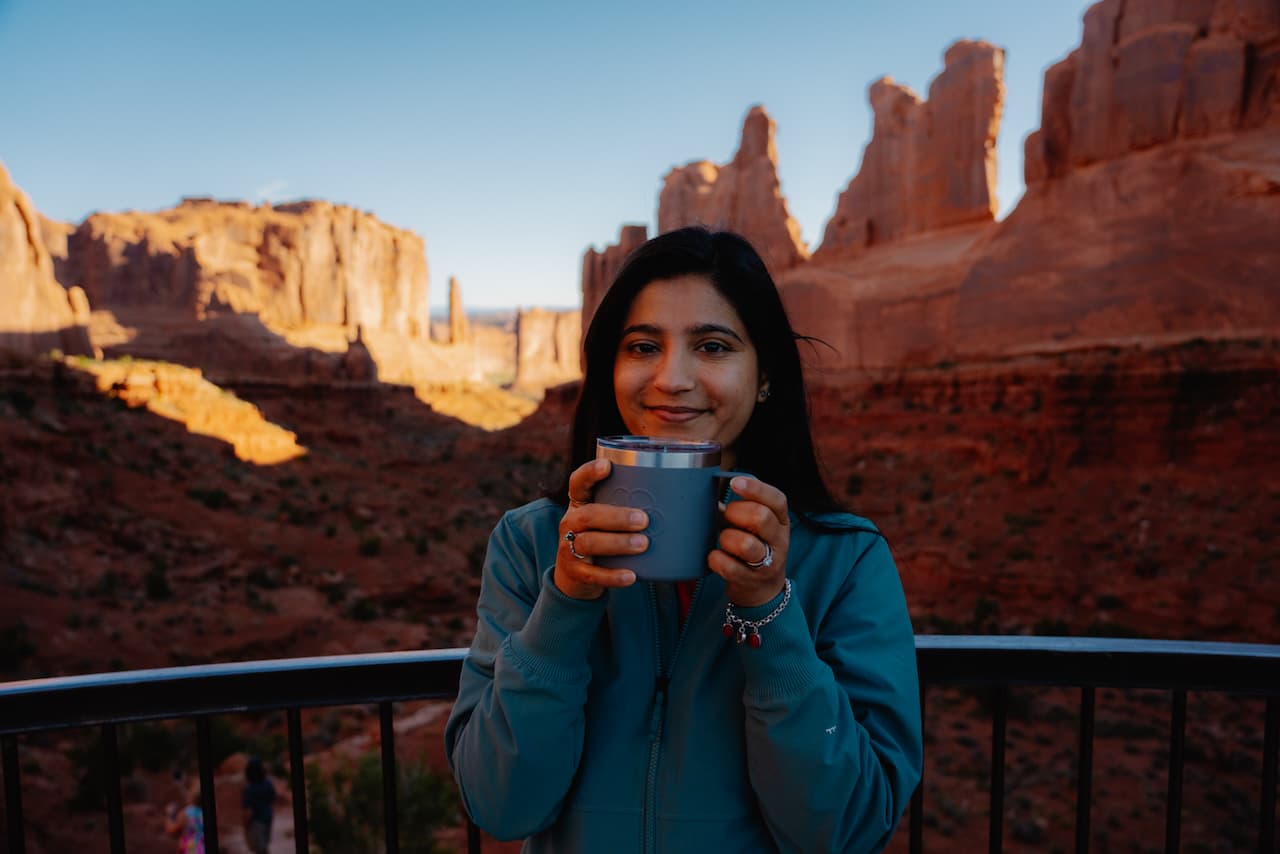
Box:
[814,41,1005,261]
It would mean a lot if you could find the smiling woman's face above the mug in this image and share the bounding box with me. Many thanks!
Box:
[613,275,763,466]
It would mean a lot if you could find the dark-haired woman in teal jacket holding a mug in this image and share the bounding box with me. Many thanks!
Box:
[445,228,922,851]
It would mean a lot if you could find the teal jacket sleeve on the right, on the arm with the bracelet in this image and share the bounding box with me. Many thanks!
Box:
[740,535,923,851]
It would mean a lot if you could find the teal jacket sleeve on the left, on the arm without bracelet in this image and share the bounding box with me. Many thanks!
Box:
[444,513,604,839]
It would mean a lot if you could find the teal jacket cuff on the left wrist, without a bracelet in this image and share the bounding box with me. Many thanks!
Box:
[504,567,608,684]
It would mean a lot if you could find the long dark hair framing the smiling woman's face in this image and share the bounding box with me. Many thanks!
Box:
[552,227,845,528]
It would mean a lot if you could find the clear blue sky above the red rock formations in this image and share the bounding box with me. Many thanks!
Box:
[0,0,1089,309]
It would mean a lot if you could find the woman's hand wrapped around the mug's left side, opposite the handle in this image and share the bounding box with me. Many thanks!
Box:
[553,460,649,599]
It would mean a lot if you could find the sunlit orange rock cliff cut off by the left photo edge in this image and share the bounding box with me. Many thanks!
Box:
[0,165,90,355]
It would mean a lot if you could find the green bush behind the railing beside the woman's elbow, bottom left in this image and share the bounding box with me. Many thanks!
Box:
[307,754,458,854]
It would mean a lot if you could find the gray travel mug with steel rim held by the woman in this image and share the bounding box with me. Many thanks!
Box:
[595,435,742,581]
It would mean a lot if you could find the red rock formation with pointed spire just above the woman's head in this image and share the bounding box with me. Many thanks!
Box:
[658,106,809,273]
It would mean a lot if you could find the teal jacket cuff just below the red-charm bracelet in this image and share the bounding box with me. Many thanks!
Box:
[733,581,827,708]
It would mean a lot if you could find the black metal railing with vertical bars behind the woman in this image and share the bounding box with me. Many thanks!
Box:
[0,635,1280,854]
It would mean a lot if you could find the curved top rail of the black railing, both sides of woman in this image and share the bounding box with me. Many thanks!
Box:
[0,635,1280,735]
